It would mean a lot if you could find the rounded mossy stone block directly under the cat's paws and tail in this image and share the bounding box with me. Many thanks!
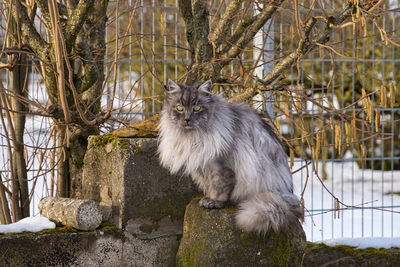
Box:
[177,198,306,266]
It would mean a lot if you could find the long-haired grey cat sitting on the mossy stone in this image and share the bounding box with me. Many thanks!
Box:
[158,80,303,234]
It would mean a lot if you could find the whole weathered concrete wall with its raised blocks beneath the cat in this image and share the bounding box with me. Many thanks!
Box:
[0,135,400,266]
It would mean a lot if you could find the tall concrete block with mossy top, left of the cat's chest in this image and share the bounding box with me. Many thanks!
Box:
[79,137,197,229]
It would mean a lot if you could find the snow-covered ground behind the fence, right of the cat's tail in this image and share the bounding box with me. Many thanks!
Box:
[292,158,400,242]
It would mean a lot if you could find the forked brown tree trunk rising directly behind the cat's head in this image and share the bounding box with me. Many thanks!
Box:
[179,0,284,84]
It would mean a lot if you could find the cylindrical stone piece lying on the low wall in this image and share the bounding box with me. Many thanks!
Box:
[39,197,102,231]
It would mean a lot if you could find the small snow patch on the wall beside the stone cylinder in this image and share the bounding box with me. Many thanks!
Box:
[0,216,56,233]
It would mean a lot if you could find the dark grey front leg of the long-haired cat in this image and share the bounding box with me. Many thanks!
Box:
[199,161,235,209]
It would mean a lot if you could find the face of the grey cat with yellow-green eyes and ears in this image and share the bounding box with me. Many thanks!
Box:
[163,80,214,131]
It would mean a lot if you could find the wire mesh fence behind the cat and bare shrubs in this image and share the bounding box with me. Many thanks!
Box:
[0,0,400,241]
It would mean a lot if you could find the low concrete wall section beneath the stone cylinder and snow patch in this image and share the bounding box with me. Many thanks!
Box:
[0,227,178,267]
